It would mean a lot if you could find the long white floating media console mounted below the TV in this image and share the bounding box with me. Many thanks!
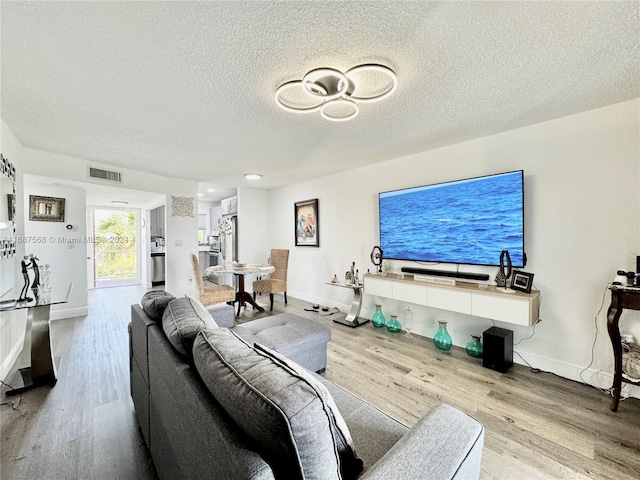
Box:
[364,274,540,326]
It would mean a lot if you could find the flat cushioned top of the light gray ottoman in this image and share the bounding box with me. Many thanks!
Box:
[233,313,331,357]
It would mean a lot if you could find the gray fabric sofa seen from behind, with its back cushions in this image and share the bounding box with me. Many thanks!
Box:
[130,290,484,480]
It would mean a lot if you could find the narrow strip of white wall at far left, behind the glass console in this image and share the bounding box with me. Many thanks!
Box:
[0,119,27,380]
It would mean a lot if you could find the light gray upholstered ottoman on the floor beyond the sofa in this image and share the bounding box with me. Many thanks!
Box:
[231,313,331,372]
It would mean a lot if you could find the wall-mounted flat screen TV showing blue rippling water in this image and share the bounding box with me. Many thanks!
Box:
[379,170,526,267]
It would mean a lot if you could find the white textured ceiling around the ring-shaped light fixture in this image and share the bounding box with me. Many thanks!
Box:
[0,1,640,193]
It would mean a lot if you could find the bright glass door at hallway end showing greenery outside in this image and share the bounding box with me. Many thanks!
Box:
[92,207,140,288]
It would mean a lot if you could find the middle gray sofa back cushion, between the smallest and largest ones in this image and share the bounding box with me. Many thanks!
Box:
[162,297,218,358]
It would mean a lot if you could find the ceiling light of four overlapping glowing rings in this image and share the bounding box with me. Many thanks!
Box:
[275,64,398,122]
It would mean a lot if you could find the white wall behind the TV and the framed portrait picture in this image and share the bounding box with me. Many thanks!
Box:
[269,99,640,396]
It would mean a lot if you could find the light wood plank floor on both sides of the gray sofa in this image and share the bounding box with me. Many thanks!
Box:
[0,287,640,480]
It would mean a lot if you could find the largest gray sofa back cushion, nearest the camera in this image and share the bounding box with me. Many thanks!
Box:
[193,328,340,480]
